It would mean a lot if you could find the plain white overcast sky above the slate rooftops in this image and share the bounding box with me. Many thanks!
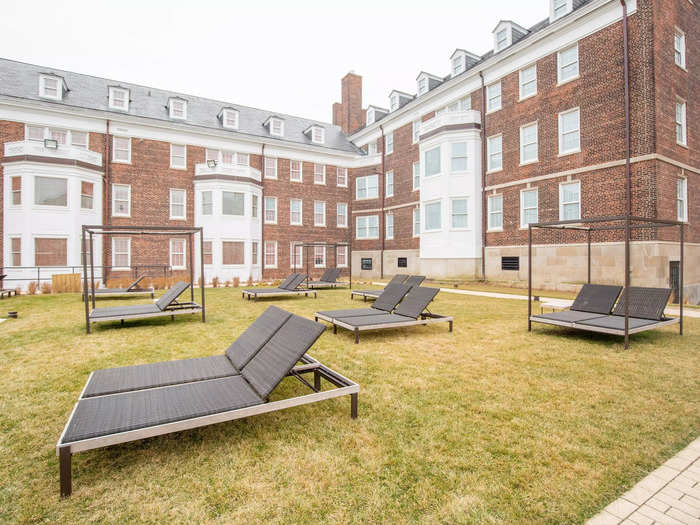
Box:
[0,0,549,122]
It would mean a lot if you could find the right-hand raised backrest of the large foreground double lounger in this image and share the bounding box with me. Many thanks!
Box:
[241,315,325,398]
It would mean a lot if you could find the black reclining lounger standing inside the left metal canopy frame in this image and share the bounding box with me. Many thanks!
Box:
[88,281,202,333]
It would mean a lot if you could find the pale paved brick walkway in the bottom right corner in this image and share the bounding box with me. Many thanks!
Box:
[586,438,700,525]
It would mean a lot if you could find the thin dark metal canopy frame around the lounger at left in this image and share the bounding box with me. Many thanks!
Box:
[82,225,206,333]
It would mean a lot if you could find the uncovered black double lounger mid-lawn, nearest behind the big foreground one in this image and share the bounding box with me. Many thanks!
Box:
[314,286,453,344]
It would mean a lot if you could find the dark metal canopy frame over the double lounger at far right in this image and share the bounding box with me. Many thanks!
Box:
[527,215,685,349]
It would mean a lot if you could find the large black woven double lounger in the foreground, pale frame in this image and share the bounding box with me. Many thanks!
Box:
[56,309,360,497]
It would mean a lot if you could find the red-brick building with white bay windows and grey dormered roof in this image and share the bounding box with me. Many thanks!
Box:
[0,0,700,298]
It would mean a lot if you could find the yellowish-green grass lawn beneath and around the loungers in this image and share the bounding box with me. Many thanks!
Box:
[0,288,700,523]
